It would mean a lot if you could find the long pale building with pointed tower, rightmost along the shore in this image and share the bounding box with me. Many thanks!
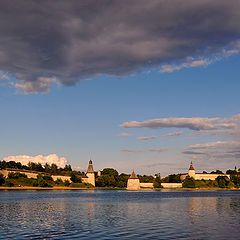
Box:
[180,162,230,181]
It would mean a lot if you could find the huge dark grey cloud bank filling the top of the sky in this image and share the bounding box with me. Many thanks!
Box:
[0,0,240,93]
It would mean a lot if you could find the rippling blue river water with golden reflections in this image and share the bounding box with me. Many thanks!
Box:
[0,190,240,239]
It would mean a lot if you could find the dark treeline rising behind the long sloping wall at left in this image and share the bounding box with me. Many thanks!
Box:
[0,160,84,176]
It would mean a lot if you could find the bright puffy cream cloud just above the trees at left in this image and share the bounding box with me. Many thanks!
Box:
[3,154,68,168]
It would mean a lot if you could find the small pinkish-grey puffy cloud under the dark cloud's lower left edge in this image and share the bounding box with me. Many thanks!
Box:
[9,77,56,94]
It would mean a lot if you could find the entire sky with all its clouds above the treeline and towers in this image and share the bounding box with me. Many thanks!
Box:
[0,0,240,176]
